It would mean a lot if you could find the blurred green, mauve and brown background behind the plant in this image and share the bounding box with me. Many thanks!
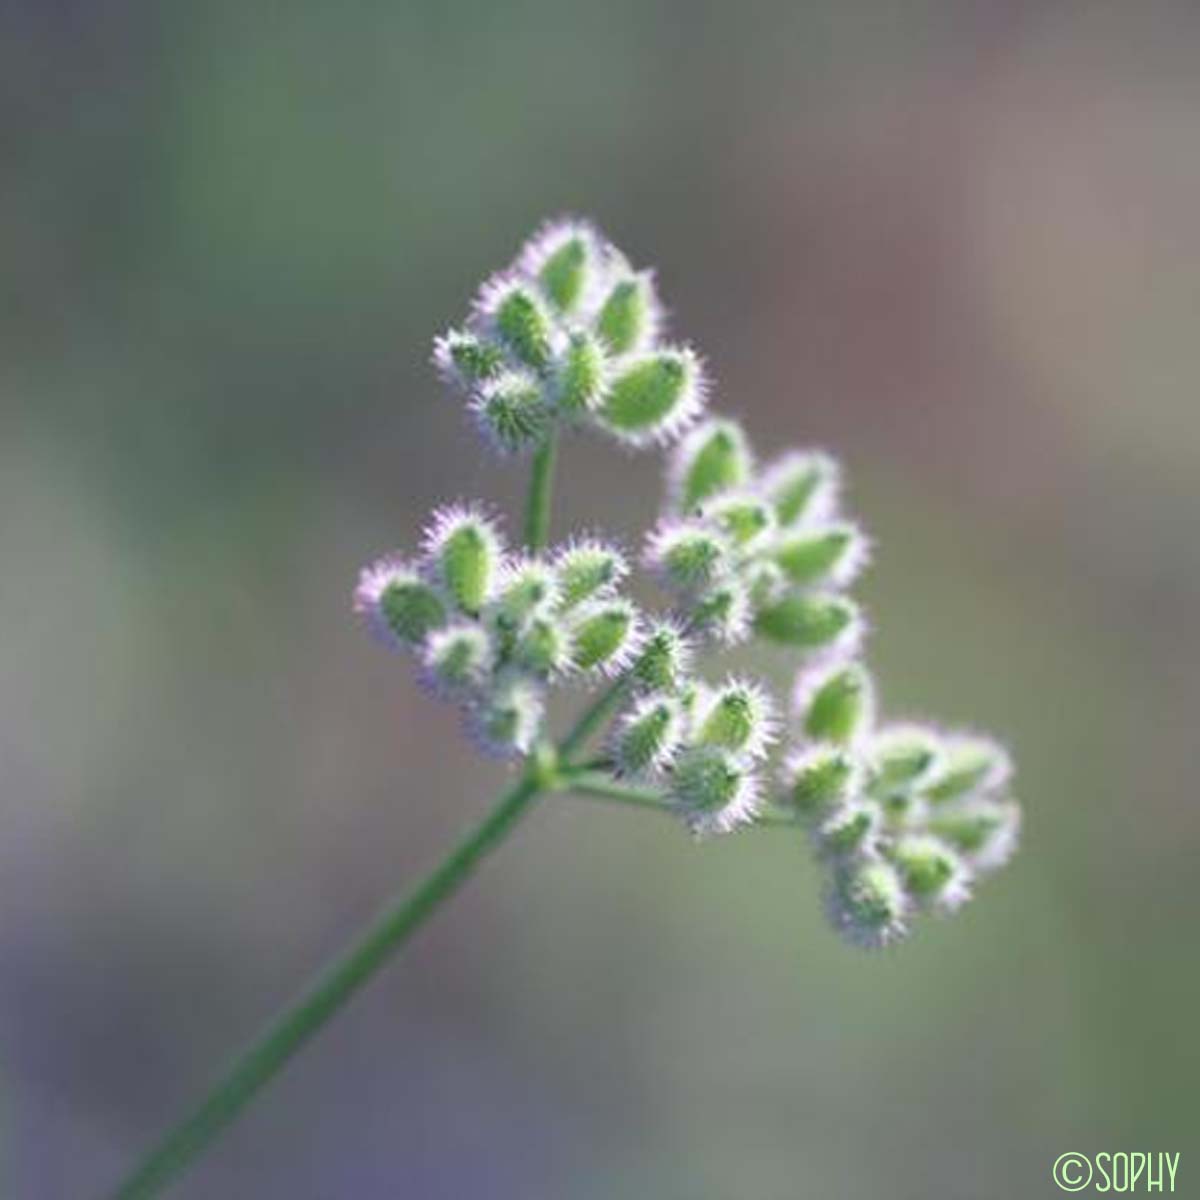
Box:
[0,0,1200,1200]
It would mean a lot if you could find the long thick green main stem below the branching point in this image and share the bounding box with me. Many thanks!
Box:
[106,770,545,1200]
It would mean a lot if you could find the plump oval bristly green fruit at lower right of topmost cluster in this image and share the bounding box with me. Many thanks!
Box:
[596,349,704,446]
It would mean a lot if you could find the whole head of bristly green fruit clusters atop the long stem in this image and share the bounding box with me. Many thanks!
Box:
[354,217,1021,947]
